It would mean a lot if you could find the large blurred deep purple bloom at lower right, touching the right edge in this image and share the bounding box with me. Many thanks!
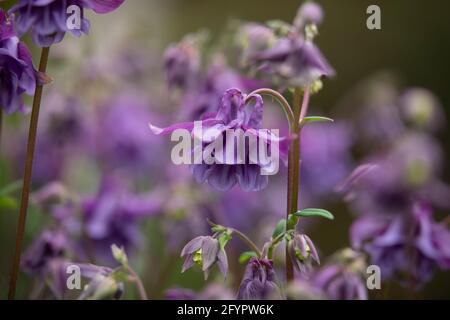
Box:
[351,203,450,287]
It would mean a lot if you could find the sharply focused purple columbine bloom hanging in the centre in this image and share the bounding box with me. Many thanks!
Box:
[150,89,283,191]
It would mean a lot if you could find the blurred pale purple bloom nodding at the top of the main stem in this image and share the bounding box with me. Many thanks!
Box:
[253,34,335,87]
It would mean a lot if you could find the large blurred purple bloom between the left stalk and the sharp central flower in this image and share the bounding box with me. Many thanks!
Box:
[82,177,165,259]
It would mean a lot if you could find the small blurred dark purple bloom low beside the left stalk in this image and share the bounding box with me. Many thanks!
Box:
[21,229,70,274]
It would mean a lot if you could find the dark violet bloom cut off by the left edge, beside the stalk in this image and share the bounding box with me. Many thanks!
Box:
[0,9,36,113]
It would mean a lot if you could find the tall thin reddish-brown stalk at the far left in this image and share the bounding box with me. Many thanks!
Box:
[8,47,50,300]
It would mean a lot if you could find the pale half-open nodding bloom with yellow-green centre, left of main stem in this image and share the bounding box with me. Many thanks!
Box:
[181,236,228,279]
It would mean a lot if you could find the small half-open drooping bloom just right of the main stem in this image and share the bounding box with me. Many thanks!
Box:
[289,234,320,276]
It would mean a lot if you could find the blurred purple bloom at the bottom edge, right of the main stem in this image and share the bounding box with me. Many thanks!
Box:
[311,264,367,300]
